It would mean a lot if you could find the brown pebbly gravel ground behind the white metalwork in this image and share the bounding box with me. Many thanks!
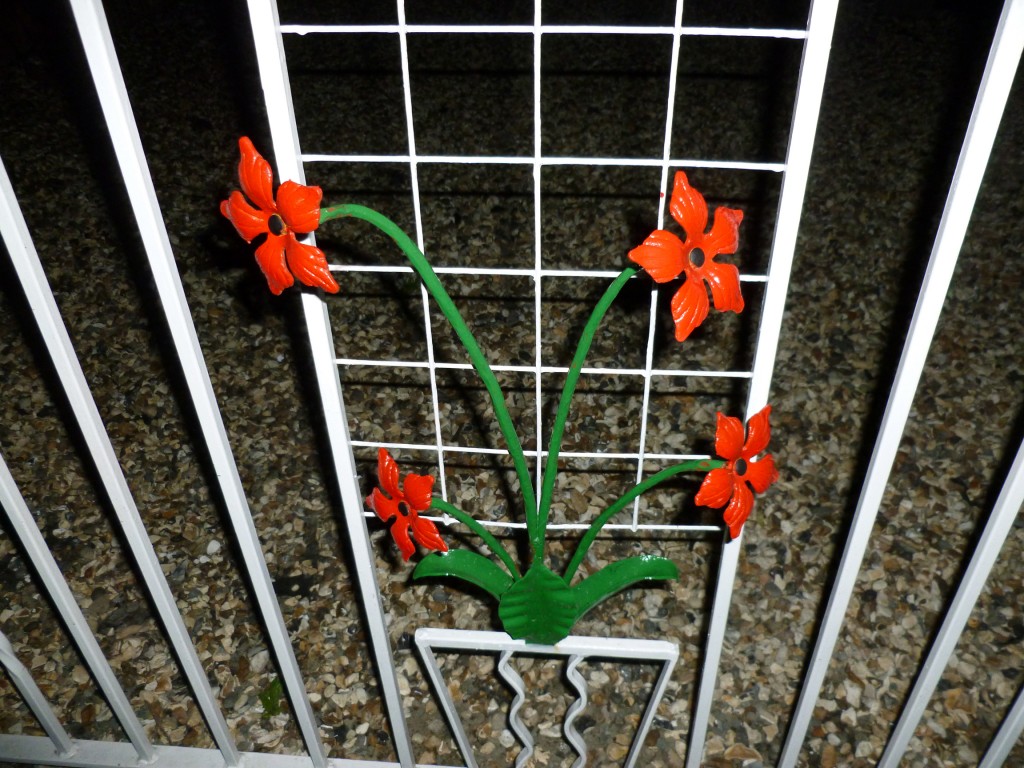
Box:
[0,0,1024,768]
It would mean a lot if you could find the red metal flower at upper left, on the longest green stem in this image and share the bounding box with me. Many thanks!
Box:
[220,136,338,296]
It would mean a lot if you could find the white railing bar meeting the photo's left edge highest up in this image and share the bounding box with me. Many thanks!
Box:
[0,148,238,766]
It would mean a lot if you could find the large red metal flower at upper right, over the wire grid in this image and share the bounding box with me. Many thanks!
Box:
[630,171,743,341]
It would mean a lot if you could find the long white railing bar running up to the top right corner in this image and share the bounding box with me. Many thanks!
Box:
[779,0,1024,768]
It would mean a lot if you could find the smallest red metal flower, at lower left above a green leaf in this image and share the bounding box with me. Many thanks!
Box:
[367,449,447,560]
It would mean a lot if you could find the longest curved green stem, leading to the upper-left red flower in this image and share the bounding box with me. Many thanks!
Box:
[319,205,543,528]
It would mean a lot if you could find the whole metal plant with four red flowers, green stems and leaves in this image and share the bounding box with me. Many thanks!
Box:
[220,138,778,644]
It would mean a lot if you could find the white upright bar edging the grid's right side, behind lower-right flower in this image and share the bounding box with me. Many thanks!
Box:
[686,0,839,768]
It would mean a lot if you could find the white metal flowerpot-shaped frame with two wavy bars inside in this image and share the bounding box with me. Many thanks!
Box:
[415,628,679,768]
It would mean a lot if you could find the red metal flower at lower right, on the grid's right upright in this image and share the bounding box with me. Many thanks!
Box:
[694,406,778,539]
